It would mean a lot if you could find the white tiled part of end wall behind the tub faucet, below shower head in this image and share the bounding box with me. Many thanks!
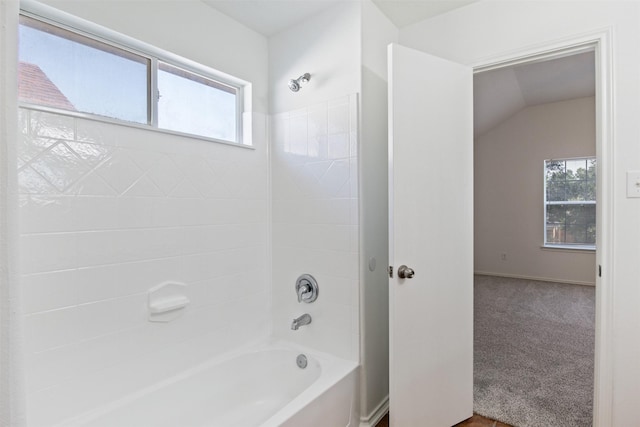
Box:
[271,95,359,361]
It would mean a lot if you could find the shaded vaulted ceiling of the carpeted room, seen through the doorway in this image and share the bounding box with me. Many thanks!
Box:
[473,52,596,136]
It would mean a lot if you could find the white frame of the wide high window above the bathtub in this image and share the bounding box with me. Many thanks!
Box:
[18,0,254,148]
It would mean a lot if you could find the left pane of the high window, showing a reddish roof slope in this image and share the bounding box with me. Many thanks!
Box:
[18,16,151,124]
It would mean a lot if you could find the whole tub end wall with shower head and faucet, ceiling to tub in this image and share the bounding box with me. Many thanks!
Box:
[269,3,360,361]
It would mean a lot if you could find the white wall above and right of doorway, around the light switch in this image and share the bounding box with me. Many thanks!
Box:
[400,1,640,427]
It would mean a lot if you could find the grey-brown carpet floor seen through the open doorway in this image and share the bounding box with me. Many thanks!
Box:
[474,276,595,427]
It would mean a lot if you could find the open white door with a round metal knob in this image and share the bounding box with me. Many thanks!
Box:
[388,45,473,427]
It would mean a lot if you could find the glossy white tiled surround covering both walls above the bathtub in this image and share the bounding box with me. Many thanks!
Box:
[18,95,359,426]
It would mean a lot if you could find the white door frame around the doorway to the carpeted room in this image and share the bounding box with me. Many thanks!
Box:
[471,28,615,427]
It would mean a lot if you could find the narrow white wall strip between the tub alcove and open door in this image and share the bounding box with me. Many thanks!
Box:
[359,1,399,426]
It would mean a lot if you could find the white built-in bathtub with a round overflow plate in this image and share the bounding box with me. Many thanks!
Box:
[62,343,359,427]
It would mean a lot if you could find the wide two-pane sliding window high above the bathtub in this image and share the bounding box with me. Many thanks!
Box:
[18,11,243,143]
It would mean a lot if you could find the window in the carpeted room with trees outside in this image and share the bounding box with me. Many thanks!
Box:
[544,157,596,249]
